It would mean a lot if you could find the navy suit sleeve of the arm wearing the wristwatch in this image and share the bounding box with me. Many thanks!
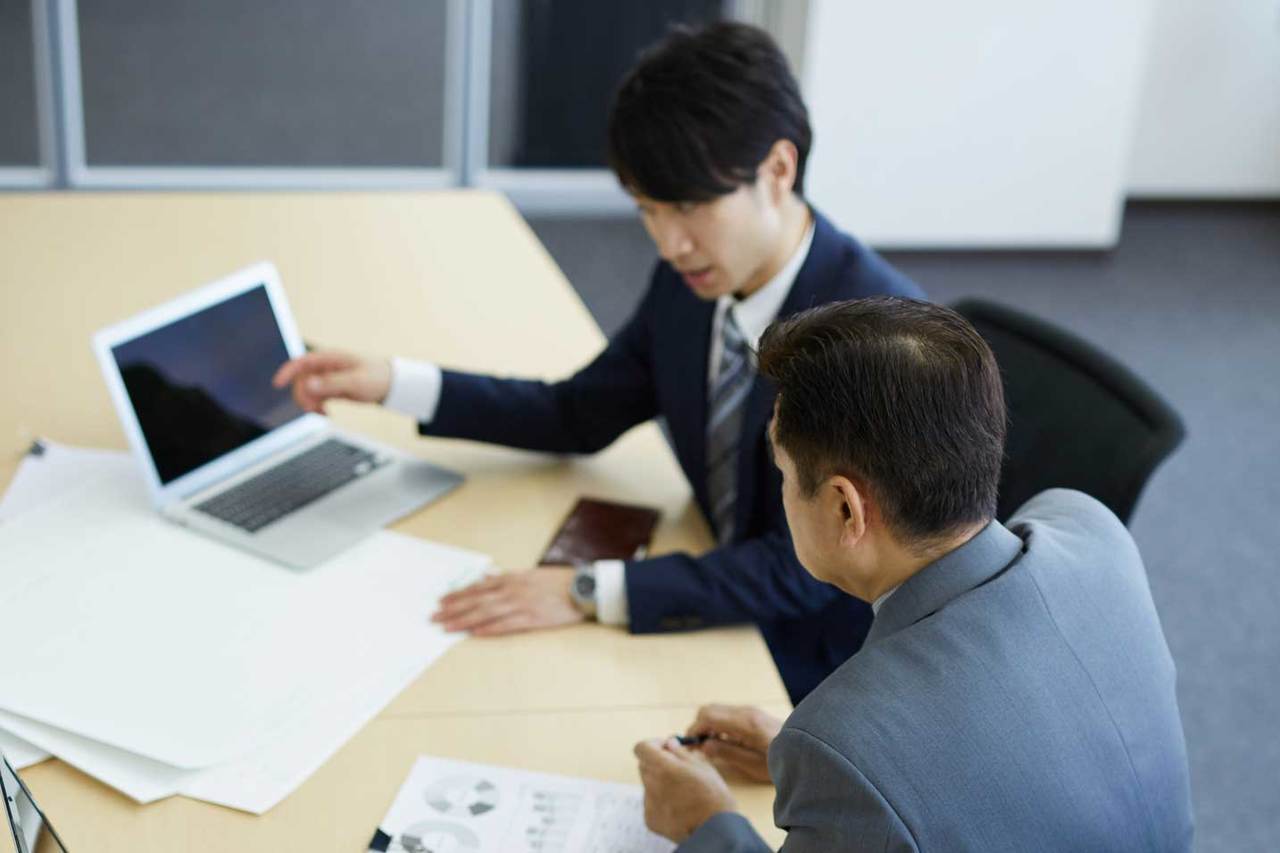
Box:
[626,528,841,634]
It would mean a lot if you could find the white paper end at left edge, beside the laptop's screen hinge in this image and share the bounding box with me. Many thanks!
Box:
[0,441,138,521]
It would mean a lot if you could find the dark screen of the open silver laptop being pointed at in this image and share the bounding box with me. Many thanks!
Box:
[111,284,303,484]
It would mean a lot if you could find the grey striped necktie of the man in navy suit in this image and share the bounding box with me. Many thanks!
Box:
[707,311,755,544]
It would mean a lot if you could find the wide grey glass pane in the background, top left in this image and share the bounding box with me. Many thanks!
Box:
[77,0,448,168]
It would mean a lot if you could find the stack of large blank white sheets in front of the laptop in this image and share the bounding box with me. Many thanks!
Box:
[0,446,488,813]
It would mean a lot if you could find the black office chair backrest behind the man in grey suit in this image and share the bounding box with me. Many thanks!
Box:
[955,300,1185,524]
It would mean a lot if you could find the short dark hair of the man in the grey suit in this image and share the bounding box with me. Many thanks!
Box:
[759,296,1006,543]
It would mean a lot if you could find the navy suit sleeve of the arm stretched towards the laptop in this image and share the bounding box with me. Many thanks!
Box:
[419,275,658,453]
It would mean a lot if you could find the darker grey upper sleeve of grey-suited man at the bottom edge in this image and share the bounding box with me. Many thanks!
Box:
[769,726,919,853]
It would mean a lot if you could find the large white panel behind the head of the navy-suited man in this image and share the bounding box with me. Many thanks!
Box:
[804,0,1162,247]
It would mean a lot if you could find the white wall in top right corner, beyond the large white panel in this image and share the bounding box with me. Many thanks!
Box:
[1129,0,1280,197]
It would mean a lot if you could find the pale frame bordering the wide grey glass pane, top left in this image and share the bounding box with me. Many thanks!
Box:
[56,0,471,190]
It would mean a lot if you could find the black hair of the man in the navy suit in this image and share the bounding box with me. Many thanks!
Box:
[608,20,813,202]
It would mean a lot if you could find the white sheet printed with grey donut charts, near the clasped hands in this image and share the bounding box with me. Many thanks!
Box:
[369,756,675,853]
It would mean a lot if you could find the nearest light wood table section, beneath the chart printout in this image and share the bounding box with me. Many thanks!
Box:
[22,703,788,853]
